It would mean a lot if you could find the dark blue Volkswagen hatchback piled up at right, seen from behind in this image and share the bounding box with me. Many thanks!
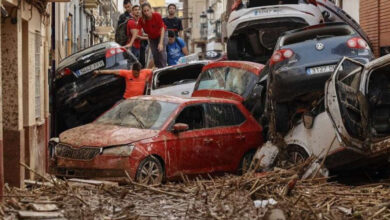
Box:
[268,23,374,133]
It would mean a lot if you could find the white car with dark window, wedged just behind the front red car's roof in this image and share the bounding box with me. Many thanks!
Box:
[146,60,210,97]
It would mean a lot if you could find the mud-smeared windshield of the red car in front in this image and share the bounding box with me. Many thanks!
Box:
[95,99,178,130]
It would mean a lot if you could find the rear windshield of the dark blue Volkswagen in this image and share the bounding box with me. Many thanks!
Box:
[280,25,355,46]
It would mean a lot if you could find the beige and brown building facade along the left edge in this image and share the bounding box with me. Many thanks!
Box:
[0,0,51,189]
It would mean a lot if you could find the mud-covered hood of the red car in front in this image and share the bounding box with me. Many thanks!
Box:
[60,123,159,147]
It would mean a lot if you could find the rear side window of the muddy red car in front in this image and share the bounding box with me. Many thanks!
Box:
[206,104,245,128]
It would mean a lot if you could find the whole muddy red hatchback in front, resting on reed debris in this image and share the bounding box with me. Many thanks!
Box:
[49,96,263,184]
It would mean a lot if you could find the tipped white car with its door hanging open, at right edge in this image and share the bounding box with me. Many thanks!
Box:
[266,55,390,171]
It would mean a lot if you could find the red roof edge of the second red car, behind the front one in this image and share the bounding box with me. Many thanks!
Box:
[203,61,264,75]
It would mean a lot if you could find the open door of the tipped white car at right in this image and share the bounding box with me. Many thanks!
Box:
[325,57,369,153]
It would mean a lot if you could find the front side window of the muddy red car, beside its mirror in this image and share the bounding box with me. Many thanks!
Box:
[175,105,205,130]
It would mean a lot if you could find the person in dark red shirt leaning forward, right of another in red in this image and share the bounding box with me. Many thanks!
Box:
[138,3,168,68]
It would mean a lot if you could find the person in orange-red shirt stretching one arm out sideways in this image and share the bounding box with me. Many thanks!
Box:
[93,63,153,99]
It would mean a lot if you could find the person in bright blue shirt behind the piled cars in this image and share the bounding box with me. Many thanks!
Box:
[167,31,188,66]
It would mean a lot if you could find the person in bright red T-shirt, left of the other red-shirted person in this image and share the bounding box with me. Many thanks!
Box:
[125,5,148,59]
